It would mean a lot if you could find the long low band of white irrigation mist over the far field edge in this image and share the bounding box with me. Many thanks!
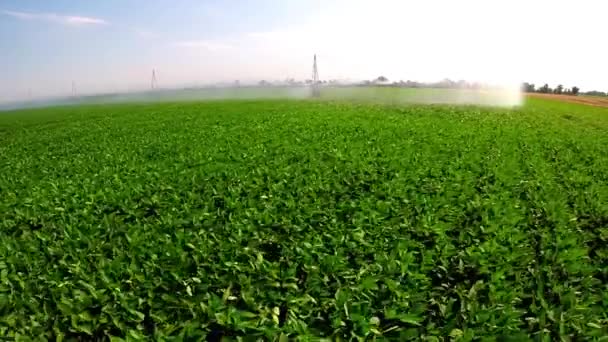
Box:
[0,86,523,110]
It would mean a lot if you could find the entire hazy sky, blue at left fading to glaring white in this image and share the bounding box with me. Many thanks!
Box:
[0,0,608,101]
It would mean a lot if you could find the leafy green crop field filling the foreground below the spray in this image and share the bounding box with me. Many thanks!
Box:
[0,95,608,341]
